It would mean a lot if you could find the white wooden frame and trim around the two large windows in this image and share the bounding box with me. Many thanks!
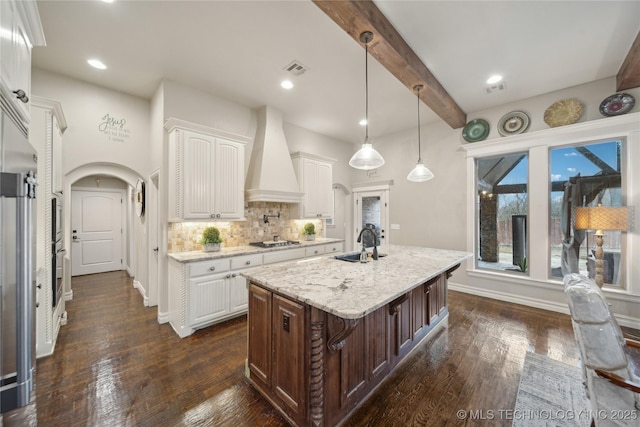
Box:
[462,113,640,294]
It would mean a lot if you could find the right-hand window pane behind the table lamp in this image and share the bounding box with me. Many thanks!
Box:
[549,140,625,286]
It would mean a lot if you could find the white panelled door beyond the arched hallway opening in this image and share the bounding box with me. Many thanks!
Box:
[71,189,124,276]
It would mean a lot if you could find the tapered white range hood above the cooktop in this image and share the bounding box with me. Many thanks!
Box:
[245,106,304,203]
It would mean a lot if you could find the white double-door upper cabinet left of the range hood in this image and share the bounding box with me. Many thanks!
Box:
[165,119,245,222]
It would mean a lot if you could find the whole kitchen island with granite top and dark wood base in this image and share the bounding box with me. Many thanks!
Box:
[242,245,471,426]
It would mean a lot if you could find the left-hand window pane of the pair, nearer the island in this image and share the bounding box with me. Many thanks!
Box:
[476,153,529,273]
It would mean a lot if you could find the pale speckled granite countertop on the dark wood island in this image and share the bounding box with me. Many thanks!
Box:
[240,245,472,319]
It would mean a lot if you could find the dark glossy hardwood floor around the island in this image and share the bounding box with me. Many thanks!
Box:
[3,272,608,427]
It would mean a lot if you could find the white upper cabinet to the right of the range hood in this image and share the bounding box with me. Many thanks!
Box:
[291,152,335,218]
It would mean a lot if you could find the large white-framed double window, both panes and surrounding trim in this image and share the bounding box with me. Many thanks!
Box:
[461,114,640,296]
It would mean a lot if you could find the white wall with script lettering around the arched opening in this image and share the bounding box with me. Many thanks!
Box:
[31,68,150,302]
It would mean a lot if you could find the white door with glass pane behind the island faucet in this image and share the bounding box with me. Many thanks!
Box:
[353,189,389,253]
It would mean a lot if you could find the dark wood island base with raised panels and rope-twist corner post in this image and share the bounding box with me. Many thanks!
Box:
[246,265,459,427]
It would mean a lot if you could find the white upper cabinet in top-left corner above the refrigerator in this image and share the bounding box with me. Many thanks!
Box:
[0,0,45,129]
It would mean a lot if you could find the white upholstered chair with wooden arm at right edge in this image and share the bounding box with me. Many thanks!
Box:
[564,274,640,427]
